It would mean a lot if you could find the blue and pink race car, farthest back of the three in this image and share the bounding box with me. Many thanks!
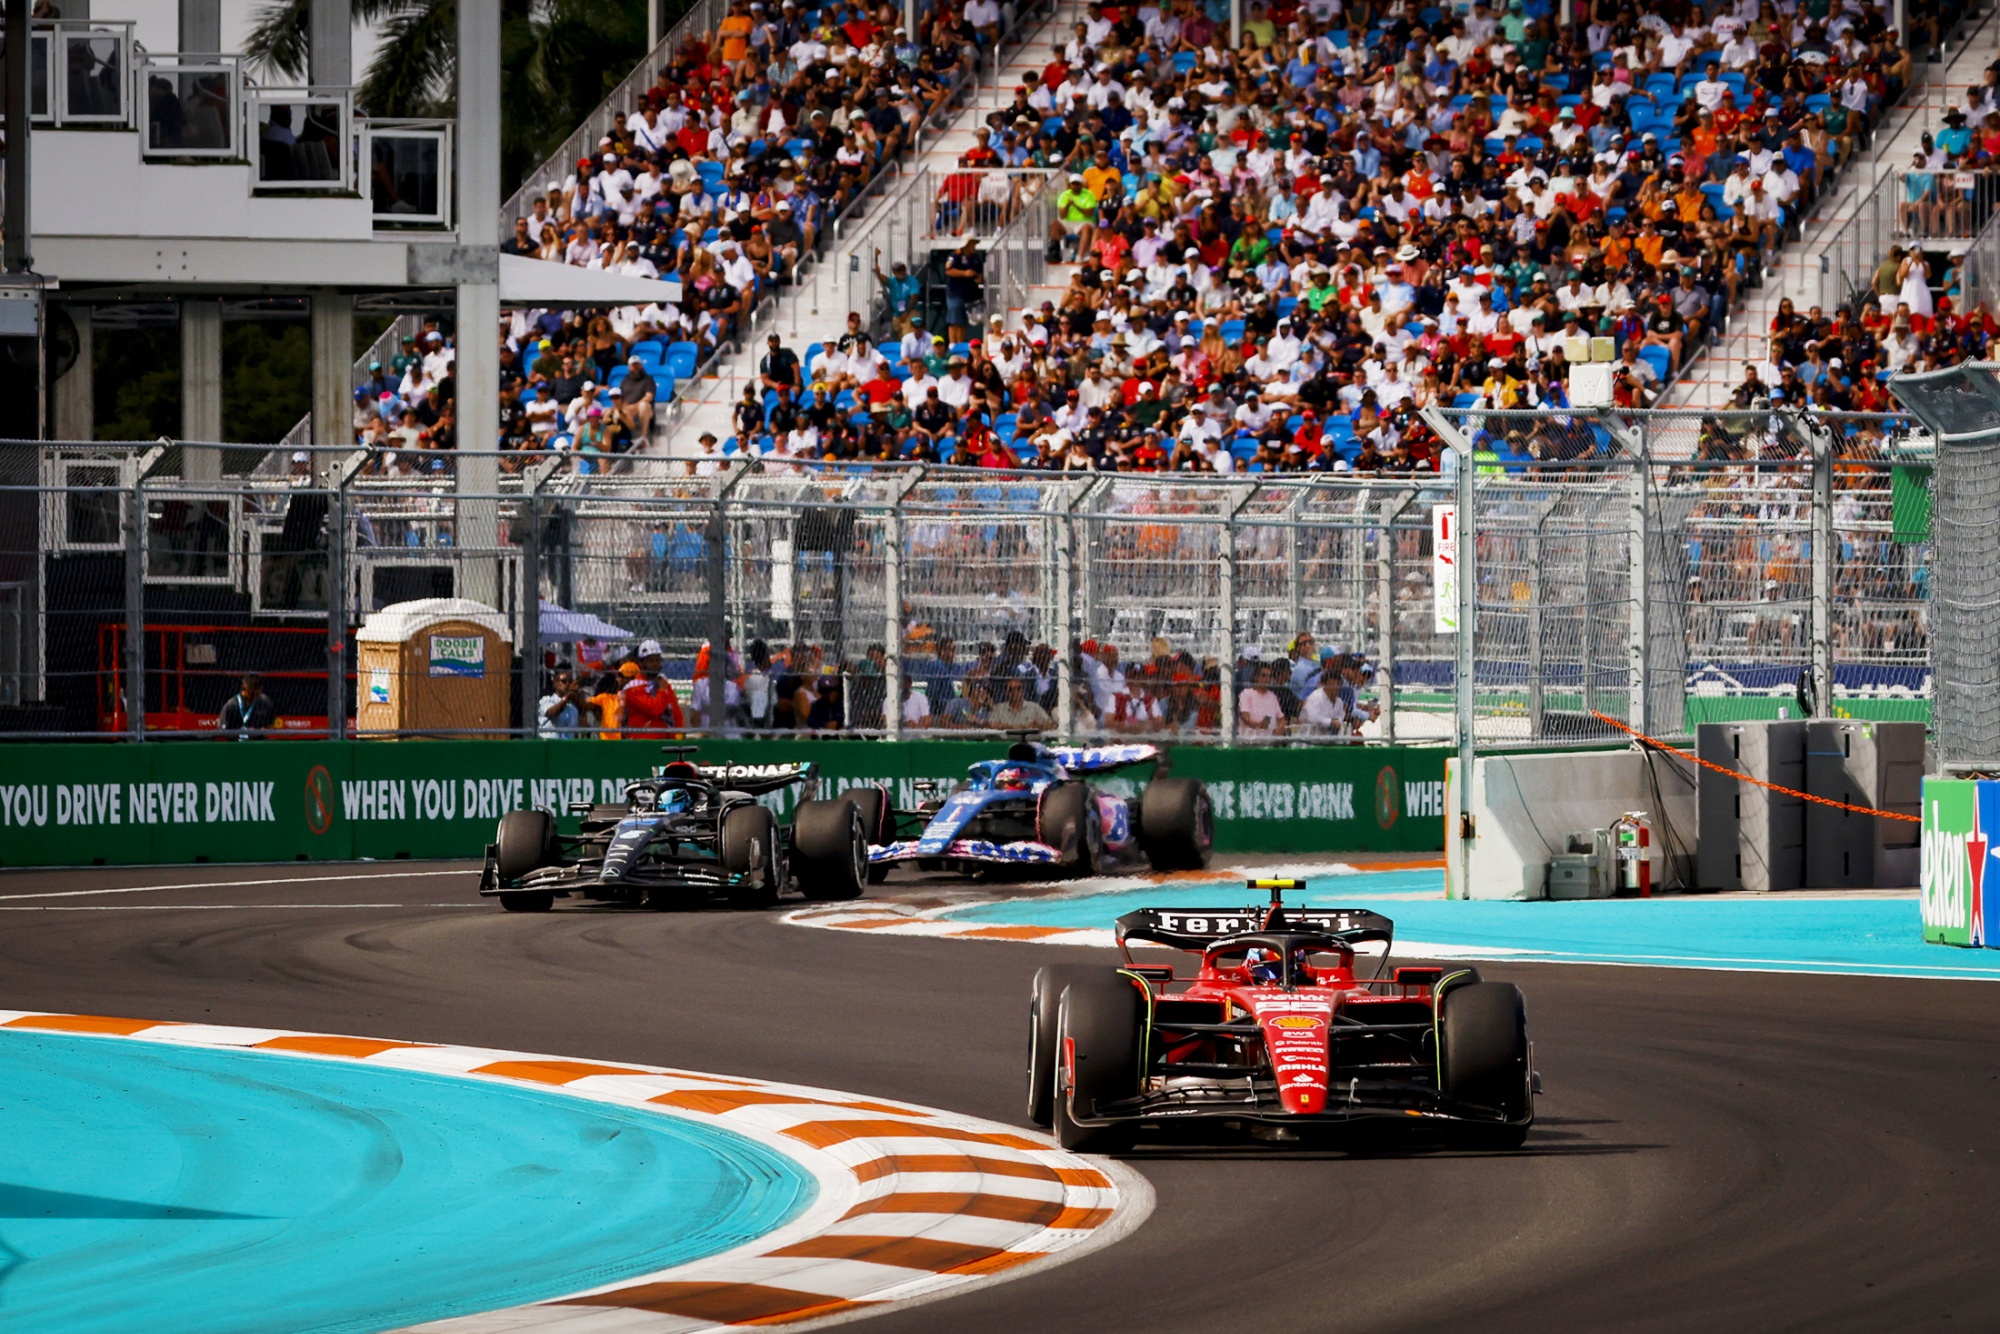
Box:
[844,740,1216,882]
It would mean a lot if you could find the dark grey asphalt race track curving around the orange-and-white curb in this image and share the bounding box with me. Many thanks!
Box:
[0,864,2000,1334]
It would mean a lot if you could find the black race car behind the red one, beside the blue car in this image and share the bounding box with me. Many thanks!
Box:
[480,746,868,912]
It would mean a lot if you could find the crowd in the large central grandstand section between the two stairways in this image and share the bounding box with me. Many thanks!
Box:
[702,0,1910,472]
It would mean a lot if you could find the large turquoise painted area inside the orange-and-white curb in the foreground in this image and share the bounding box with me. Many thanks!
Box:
[0,1032,816,1334]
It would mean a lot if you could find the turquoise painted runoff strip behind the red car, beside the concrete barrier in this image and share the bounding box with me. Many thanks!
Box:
[950,870,2000,980]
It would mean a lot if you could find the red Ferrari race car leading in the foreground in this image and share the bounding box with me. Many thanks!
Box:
[1028,880,1540,1152]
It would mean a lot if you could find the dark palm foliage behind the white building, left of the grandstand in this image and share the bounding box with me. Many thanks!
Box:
[244,0,648,190]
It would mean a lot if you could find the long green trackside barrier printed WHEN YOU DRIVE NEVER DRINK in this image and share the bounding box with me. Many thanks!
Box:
[0,738,1446,866]
